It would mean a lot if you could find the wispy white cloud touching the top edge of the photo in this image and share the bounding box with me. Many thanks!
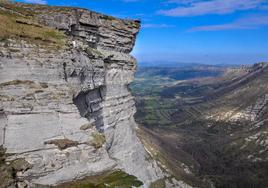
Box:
[158,0,265,16]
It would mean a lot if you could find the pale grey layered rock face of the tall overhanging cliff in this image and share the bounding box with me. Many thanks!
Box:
[0,4,163,187]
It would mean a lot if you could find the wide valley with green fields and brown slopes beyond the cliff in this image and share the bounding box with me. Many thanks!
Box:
[132,63,268,188]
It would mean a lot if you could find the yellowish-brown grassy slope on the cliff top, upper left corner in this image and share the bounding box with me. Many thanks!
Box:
[0,0,66,47]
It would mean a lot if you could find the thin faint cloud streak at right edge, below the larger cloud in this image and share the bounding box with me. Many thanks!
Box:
[189,15,268,31]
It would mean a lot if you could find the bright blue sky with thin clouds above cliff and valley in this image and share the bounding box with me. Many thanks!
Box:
[18,0,268,64]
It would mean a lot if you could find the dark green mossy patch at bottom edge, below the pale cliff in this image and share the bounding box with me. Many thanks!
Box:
[56,170,143,188]
